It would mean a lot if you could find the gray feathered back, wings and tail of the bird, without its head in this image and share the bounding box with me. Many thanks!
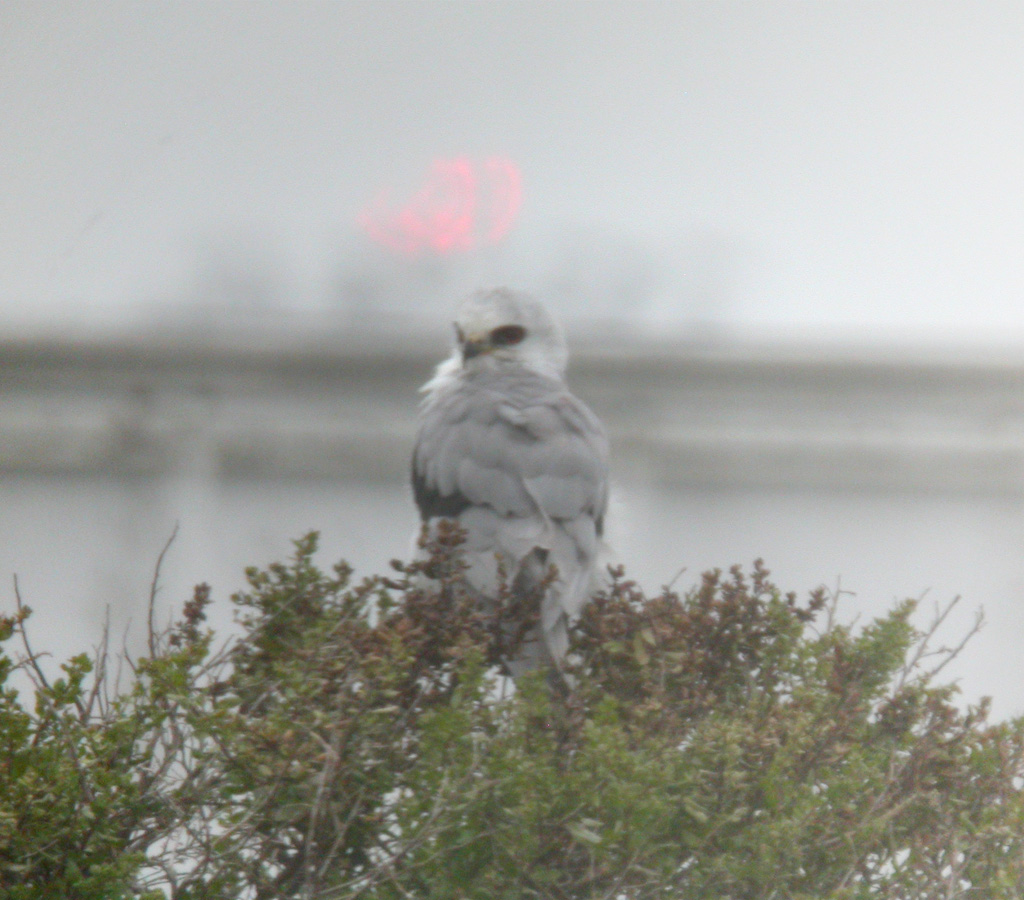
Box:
[413,373,608,675]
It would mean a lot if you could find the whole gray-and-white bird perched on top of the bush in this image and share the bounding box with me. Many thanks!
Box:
[412,288,608,679]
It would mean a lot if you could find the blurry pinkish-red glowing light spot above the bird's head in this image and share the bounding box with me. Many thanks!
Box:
[359,157,522,256]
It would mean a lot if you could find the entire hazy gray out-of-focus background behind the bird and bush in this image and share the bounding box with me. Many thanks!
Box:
[0,0,1024,715]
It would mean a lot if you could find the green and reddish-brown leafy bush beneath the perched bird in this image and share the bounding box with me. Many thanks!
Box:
[0,530,1024,900]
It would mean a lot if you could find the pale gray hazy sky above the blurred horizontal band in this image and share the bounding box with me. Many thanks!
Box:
[6,0,1024,341]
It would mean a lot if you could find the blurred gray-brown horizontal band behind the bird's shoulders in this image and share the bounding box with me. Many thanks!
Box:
[8,330,1024,496]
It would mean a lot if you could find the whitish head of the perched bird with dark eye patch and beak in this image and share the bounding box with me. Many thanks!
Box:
[455,289,568,376]
